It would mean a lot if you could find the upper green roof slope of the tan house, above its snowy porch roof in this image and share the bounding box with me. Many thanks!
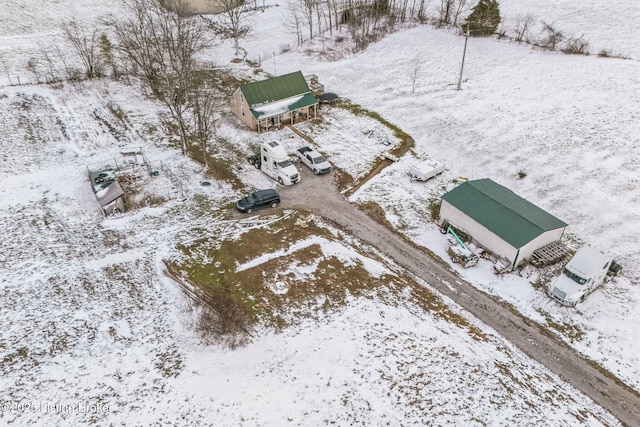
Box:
[240,71,311,107]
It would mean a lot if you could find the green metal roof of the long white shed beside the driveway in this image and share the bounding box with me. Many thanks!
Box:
[442,179,567,248]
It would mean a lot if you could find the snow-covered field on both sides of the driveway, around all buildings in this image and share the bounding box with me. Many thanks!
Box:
[0,0,640,426]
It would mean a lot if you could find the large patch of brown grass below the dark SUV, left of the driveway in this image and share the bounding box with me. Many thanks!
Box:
[168,212,486,343]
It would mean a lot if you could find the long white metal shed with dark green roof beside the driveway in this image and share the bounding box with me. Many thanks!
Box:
[440,179,567,268]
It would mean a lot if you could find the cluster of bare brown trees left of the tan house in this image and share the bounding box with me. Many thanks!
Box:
[26,0,229,164]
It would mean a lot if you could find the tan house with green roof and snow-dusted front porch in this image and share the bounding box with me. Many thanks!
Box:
[231,71,319,132]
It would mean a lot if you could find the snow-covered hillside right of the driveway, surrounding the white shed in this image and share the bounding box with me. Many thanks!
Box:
[255,2,640,389]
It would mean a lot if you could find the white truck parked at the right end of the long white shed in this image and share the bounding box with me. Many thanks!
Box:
[547,247,622,307]
